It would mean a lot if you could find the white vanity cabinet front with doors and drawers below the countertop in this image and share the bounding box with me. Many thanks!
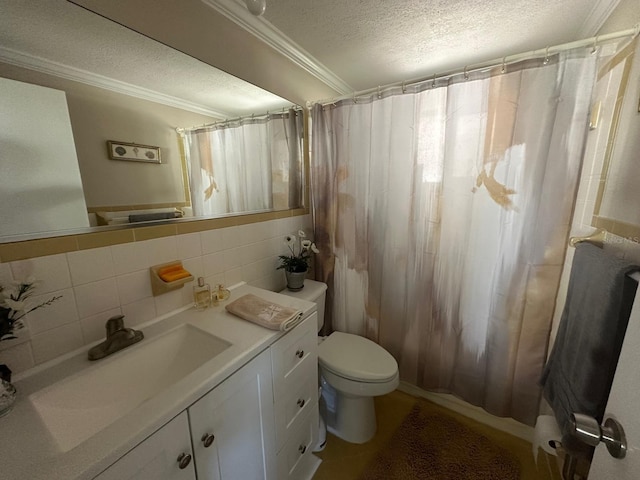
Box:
[94,314,320,480]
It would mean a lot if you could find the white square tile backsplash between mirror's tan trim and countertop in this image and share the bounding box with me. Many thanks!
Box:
[0,215,311,373]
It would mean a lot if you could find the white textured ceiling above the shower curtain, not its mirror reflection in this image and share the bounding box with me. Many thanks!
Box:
[264,0,620,90]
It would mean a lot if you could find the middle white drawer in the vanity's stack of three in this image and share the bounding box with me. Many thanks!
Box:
[275,368,318,451]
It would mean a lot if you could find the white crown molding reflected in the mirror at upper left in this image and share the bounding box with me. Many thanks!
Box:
[0,46,233,118]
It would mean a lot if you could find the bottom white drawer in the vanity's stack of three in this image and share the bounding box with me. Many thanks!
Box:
[277,408,318,480]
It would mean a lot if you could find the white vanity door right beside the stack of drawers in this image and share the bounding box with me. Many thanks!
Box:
[188,350,276,480]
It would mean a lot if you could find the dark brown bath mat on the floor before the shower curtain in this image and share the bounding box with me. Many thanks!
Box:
[360,401,520,480]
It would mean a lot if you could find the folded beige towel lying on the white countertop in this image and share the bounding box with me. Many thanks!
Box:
[225,293,302,332]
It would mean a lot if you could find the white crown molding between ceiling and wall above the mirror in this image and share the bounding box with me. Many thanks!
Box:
[202,0,353,95]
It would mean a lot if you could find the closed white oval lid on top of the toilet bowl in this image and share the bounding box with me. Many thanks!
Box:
[318,332,398,382]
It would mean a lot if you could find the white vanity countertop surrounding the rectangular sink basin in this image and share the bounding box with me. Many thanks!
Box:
[0,284,316,480]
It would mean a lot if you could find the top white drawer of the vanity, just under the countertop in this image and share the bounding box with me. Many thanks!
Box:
[272,313,318,399]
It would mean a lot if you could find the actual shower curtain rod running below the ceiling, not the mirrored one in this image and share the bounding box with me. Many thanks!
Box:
[316,23,640,106]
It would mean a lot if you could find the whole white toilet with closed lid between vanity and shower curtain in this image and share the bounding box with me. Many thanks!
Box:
[280,280,400,443]
